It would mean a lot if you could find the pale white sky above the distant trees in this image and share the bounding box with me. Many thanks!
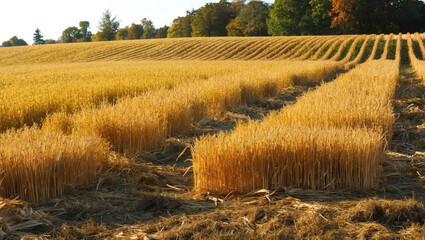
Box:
[0,0,274,44]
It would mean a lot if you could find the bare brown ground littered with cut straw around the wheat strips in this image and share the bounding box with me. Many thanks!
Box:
[11,67,425,239]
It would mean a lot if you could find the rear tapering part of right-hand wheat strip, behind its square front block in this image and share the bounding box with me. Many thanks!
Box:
[274,60,399,139]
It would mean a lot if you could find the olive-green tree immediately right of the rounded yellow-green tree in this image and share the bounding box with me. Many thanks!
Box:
[235,1,269,36]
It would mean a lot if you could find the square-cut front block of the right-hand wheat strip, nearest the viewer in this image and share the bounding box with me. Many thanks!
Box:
[192,124,383,194]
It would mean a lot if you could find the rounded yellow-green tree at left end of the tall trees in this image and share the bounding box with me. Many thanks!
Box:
[191,0,234,37]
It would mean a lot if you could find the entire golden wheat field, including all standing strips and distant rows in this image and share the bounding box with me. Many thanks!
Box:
[0,34,418,203]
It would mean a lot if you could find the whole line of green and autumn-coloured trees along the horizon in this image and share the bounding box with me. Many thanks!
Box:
[2,0,425,47]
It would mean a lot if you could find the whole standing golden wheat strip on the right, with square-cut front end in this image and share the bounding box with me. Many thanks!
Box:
[192,60,398,194]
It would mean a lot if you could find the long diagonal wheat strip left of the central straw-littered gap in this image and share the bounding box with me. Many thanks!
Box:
[54,62,337,154]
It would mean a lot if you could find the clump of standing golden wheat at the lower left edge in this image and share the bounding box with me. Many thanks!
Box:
[0,127,109,203]
